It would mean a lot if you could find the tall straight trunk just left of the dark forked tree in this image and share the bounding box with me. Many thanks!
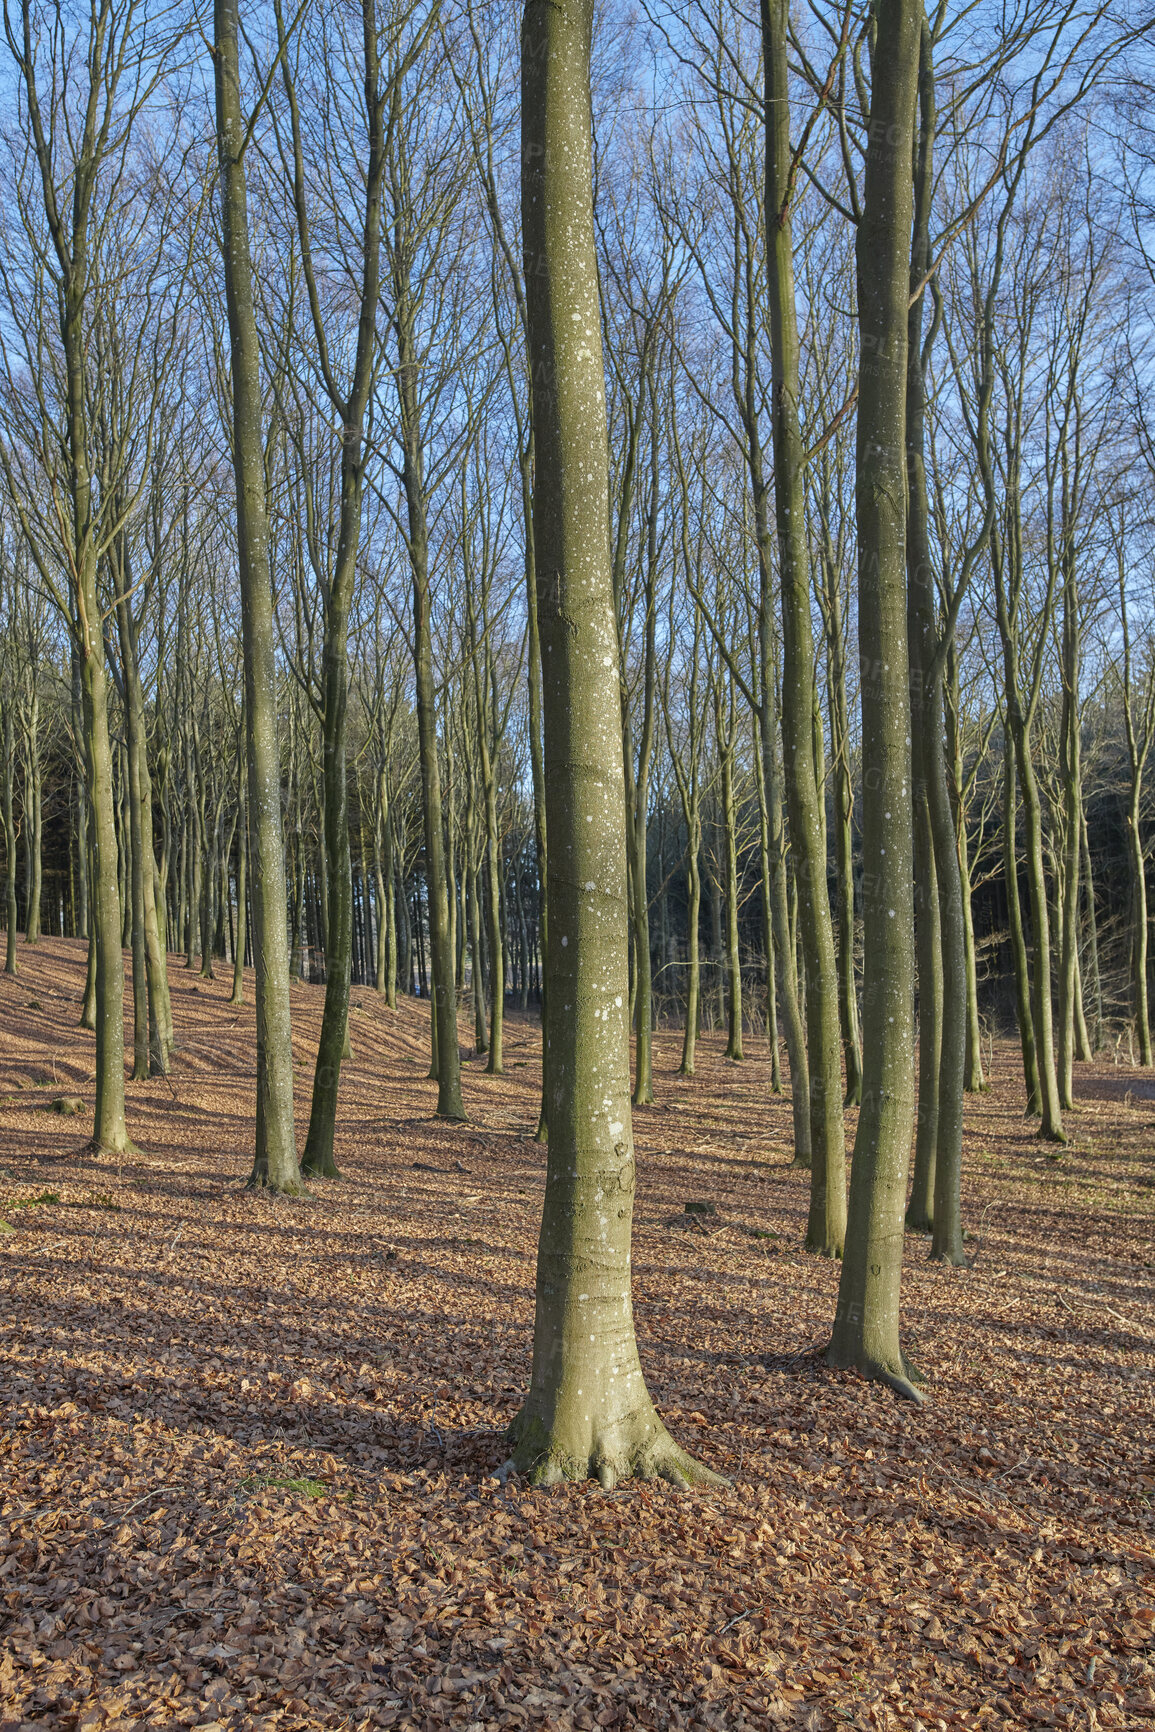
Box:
[213,0,301,1195]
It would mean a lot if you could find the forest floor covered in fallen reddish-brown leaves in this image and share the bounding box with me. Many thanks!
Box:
[0,940,1155,1732]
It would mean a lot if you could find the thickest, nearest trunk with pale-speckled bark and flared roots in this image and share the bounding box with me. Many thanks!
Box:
[511,0,716,1486]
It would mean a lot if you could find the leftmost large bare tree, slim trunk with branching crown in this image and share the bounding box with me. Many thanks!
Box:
[0,0,174,1159]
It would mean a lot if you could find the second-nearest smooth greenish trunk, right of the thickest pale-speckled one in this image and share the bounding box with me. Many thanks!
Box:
[826,0,923,1399]
